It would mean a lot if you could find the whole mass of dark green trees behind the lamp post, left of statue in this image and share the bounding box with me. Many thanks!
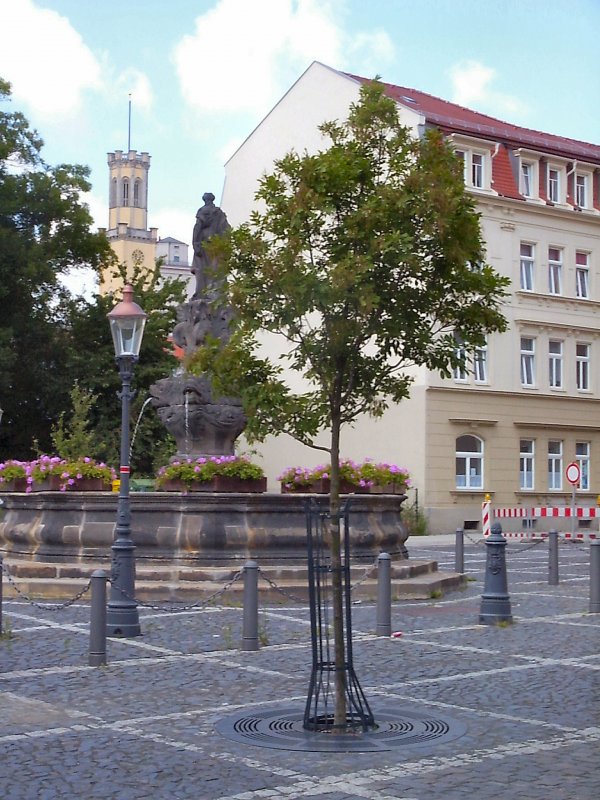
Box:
[0,79,184,474]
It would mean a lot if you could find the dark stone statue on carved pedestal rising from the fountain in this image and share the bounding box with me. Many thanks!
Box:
[150,192,246,458]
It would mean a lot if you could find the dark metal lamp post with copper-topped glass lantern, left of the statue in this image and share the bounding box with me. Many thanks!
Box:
[106,285,146,638]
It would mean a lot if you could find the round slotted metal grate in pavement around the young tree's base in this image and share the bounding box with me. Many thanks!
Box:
[215,706,466,753]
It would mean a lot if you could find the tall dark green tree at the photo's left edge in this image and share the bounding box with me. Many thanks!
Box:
[0,79,112,458]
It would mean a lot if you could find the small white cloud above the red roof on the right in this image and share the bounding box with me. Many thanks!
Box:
[450,61,527,116]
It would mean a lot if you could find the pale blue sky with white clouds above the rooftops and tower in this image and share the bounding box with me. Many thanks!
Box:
[0,0,600,284]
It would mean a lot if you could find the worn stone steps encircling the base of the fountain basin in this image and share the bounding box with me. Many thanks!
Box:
[4,560,465,605]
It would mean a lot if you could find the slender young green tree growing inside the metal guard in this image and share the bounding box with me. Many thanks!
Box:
[191,82,508,724]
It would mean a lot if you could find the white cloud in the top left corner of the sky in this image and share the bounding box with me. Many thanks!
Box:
[0,0,102,116]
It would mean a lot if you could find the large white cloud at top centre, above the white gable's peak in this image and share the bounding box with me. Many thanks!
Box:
[174,0,393,115]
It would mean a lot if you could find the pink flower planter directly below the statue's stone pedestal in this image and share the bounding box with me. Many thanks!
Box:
[156,456,267,493]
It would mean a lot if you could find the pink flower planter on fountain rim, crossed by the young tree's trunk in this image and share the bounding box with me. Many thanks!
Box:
[277,459,410,494]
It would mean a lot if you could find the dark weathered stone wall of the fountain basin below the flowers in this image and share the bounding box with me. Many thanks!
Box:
[0,492,408,564]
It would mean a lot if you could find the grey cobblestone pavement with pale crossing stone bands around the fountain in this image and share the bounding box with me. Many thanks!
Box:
[0,539,600,800]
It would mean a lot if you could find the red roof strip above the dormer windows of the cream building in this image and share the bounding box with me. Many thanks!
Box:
[343,73,600,163]
